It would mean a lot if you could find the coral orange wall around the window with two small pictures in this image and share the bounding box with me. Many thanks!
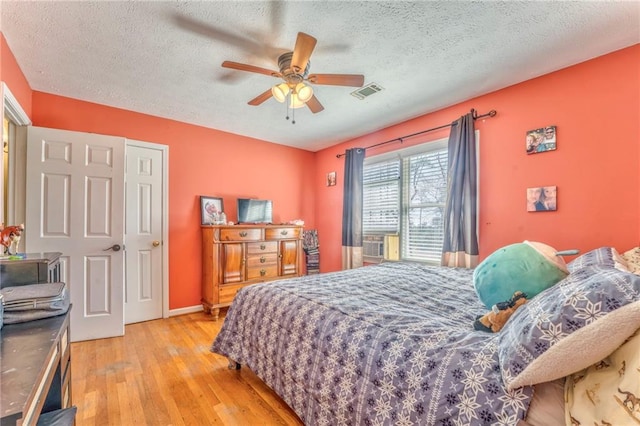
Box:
[315,45,640,272]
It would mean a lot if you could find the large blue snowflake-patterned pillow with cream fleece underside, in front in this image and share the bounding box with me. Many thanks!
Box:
[498,265,640,390]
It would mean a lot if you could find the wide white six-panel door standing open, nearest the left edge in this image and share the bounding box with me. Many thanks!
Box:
[25,127,125,341]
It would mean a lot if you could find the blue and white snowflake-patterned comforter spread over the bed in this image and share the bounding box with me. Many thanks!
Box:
[211,262,533,426]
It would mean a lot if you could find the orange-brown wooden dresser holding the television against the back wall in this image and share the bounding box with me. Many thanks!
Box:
[202,225,303,319]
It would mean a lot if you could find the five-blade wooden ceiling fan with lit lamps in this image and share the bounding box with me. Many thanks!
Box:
[222,32,364,114]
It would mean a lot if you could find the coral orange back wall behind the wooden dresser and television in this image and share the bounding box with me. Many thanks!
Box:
[32,92,315,309]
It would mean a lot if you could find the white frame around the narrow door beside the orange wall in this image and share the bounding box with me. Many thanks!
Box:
[125,139,169,318]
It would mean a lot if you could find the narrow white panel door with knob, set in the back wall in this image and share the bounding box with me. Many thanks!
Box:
[124,141,165,324]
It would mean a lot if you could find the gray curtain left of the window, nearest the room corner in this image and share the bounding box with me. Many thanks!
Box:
[342,148,365,269]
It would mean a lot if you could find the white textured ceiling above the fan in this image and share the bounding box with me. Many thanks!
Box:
[0,0,640,151]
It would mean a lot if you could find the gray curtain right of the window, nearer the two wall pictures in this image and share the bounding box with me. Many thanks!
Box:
[442,112,478,268]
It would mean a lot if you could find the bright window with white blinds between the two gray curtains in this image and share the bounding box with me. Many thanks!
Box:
[363,140,447,264]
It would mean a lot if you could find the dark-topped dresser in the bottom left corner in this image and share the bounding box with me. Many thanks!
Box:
[0,312,71,426]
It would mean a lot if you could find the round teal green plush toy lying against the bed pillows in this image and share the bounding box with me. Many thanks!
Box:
[473,241,569,309]
